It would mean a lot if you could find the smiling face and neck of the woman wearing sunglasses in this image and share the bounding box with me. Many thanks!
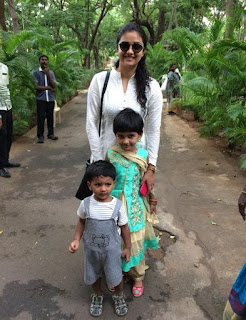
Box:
[118,31,145,70]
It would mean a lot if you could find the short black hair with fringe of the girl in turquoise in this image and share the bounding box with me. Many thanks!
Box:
[113,108,144,134]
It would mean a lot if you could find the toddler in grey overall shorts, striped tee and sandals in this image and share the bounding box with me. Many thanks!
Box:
[69,160,131,316]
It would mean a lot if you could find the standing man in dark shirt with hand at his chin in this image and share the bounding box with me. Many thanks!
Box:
[33,54,58,143]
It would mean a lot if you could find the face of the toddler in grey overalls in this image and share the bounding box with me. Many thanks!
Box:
[87,176,115,202]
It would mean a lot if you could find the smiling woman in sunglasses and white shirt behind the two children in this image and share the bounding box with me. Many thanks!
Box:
[86,22,162,191]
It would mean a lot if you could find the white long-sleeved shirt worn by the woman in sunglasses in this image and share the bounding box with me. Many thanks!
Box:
[86,68,163,165]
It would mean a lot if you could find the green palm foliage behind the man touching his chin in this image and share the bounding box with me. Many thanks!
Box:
[0,27,96,135]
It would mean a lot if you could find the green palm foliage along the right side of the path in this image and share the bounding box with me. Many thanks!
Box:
[149,20,246,169]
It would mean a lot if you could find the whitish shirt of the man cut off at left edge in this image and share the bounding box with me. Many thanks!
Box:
[0,62,12,111]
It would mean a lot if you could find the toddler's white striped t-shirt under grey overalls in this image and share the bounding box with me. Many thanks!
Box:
[77,195,128,234]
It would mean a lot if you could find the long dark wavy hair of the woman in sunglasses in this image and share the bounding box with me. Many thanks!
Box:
[115,22,151,115]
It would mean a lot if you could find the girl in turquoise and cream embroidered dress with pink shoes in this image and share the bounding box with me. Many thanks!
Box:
[107,108,158,297]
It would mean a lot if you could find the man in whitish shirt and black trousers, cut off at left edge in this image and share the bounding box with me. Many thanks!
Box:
[0,62,20,178]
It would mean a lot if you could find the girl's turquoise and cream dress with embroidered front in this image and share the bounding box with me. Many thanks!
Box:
[107,149,158,272]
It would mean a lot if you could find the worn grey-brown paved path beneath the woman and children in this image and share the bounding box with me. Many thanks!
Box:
[0,93,246,320]
